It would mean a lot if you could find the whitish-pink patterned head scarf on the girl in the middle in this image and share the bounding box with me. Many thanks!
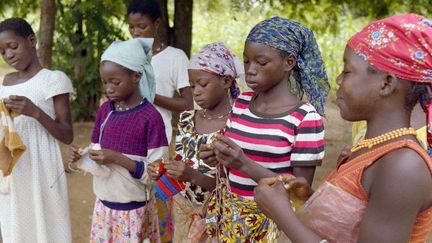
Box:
[188,42,244,99]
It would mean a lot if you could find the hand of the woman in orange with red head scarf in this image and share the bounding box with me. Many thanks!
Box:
[254,178,291,218]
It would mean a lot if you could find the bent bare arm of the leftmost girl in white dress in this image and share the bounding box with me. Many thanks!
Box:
[5,94,73,144]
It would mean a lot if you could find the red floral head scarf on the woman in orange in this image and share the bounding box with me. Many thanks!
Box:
[348,14,432,154]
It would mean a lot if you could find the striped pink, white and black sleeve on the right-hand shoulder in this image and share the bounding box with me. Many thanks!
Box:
[291,112,324,166]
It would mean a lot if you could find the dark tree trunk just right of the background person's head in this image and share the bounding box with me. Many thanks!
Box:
[174,0,193,57]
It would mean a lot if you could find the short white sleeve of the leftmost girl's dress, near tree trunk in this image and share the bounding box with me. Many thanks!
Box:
[45,71,73,100]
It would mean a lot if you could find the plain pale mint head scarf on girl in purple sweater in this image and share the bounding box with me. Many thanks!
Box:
[101,38,156,103]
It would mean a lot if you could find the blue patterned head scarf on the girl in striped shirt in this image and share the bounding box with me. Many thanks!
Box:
[246,17,330,115]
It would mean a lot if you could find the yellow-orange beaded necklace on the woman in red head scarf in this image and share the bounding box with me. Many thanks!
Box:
[351,127,417,153]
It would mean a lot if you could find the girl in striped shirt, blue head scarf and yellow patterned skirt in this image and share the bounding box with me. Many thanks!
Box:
[200,17,330,241]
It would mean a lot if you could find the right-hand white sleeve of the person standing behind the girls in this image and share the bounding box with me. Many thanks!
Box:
[172,49,189,93]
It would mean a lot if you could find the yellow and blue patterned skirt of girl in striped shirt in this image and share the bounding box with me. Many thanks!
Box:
[205,170,279,243]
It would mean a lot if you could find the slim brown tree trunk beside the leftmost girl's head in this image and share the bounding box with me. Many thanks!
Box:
[38,0,56,68]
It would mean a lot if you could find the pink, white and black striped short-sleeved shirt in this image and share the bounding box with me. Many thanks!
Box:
[225,92,324,199]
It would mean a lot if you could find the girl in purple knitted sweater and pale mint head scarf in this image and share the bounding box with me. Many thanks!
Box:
[67,38,167,242]
